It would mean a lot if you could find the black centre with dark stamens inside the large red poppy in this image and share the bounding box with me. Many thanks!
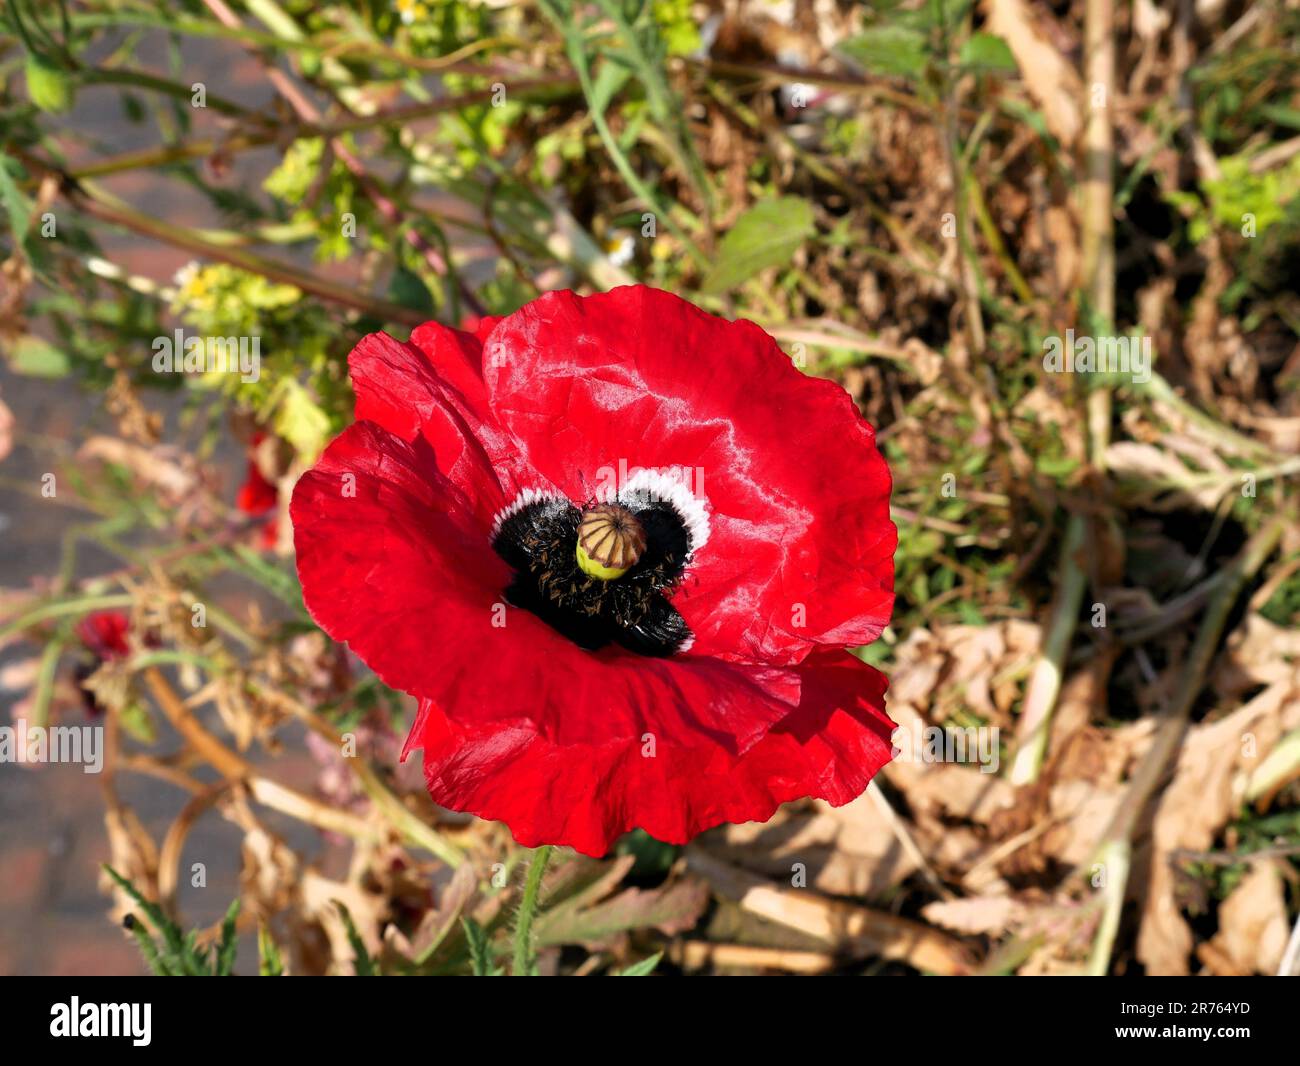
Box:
[493,493,690,655]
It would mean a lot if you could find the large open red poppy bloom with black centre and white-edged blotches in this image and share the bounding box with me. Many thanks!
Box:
[291,286,897,855]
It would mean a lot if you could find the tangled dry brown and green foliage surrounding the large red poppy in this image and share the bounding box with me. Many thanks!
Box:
[0,0,1300,974]
